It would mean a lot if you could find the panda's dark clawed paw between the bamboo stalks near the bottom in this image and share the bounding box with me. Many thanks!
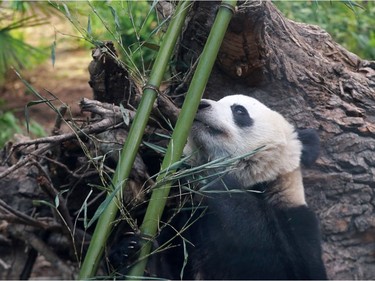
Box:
[108,232,142,275]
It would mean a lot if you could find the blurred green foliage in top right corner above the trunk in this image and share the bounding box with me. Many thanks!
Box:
[274,0,375,59]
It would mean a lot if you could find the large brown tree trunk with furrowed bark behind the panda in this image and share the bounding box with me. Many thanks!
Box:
[173,1,375,279]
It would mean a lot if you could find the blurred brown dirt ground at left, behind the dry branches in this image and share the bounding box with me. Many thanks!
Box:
[0,49,92,134]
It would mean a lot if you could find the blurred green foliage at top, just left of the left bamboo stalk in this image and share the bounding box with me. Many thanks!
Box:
[53,0,162,79]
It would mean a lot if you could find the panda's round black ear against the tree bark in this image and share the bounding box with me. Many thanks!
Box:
[297,129,320,167]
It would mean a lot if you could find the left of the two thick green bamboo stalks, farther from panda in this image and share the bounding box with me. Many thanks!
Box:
[79,1,190,280]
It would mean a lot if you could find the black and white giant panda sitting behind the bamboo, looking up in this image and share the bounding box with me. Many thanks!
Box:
[112,95,327,280]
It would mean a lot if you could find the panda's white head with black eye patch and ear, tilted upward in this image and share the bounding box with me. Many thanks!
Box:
[184,95,319,194]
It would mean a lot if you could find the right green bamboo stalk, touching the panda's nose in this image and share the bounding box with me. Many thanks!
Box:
[129,0,237,278]
